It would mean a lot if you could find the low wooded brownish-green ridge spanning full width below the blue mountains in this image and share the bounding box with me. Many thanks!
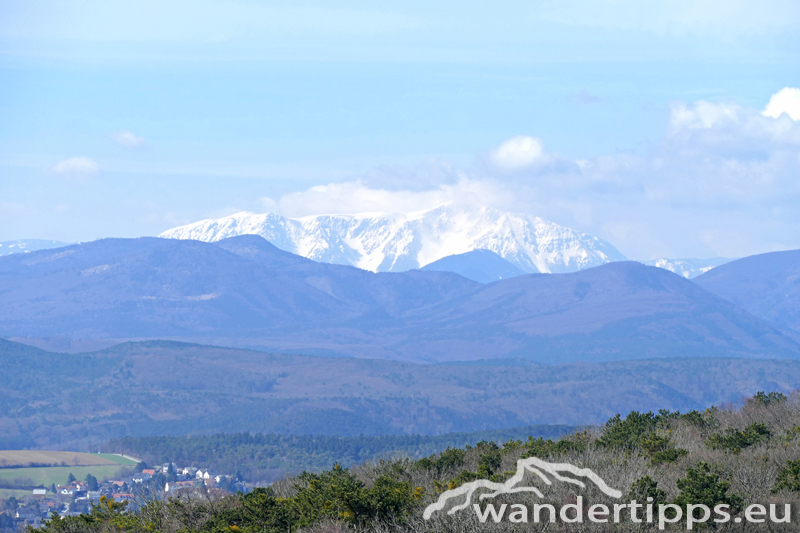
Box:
[0,341,800,449]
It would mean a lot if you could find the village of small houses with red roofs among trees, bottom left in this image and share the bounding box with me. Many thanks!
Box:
[0,463,244,532]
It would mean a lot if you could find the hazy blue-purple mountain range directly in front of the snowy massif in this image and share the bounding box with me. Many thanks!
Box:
[0,235,800,363]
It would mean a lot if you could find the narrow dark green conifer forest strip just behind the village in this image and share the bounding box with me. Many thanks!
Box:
[101,425,575,482]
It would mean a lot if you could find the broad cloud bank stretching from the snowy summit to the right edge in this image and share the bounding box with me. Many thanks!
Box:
[265,88,800,259]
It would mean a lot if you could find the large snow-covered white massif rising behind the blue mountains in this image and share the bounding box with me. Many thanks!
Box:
[160,204,625,273]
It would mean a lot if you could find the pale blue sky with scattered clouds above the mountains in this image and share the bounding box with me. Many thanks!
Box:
[0,0,800,259]
